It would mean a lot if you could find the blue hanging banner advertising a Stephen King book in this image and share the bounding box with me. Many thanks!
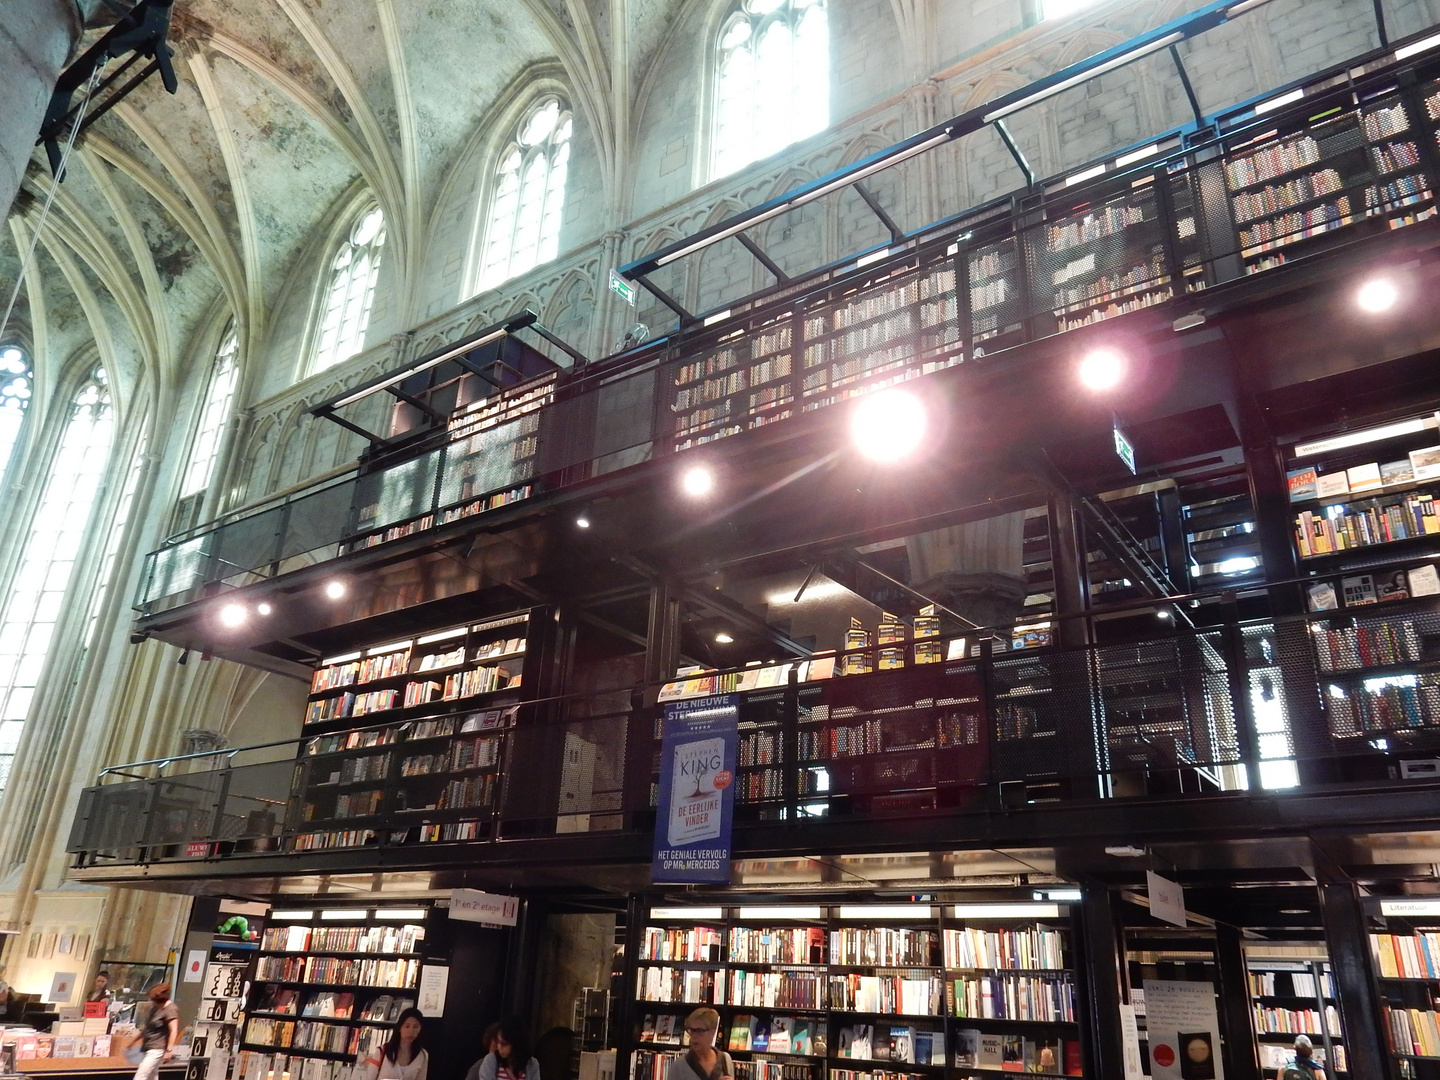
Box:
[651,694,739,884]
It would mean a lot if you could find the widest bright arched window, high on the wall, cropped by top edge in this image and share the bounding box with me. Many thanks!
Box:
[710,0,829,177]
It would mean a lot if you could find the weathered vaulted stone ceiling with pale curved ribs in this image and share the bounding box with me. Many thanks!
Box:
[0,0,685,400]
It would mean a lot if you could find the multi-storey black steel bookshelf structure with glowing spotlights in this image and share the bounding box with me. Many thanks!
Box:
[42,10,1440,1080]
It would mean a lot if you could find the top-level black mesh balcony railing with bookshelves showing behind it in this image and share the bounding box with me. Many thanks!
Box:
[137,23,1440,613]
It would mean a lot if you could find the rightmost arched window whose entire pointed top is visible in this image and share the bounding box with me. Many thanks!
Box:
[471,98,575,292]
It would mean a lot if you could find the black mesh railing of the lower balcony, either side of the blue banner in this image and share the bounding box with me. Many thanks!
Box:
[68,585,1440,873]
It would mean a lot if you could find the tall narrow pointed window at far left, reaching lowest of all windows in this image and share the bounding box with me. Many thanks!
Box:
[0,367,114,792]
